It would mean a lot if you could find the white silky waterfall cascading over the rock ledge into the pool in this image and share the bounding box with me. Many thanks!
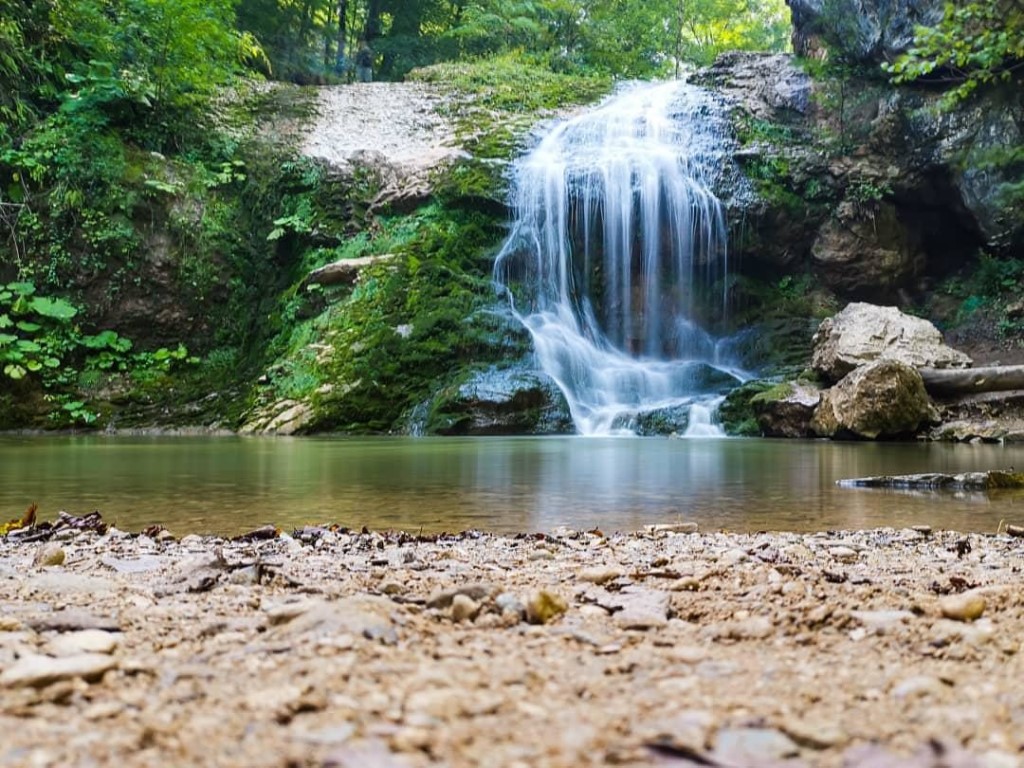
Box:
[495,82,744,435]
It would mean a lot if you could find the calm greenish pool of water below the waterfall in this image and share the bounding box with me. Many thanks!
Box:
[0,436,1024,535]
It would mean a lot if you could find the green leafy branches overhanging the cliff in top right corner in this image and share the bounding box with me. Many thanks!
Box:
[885,0,1024,105]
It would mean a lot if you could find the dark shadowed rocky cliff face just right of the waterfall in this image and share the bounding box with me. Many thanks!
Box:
[701,54,1024,331]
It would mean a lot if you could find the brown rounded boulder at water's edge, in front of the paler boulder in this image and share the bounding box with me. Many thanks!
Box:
[812,359,938,440]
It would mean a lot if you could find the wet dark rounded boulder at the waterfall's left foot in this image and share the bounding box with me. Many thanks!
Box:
[413,367,573,435]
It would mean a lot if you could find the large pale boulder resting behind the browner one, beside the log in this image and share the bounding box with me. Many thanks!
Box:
[811,302,972,382]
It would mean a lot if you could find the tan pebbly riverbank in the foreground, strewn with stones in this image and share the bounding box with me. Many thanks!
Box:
[0,518,1024,768]
